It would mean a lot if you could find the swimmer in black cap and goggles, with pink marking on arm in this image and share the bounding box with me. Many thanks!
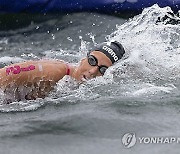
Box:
[0,41,125,101]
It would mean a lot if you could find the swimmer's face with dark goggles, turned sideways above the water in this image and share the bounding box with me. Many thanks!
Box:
[74,51,112,81]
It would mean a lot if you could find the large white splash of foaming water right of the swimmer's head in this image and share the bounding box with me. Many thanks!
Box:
[65,5,180,103]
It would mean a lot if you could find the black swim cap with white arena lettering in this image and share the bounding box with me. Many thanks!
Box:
[91,41,125,64]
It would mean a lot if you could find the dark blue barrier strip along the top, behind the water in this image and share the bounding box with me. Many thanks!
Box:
[0,0,180,13]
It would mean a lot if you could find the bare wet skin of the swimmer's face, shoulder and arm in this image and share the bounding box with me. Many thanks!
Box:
[0,51,112,100]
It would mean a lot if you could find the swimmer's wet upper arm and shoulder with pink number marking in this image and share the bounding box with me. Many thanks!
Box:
[0,60,66,87]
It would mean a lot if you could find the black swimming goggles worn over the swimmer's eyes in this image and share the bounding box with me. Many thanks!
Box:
[87,54,108,75]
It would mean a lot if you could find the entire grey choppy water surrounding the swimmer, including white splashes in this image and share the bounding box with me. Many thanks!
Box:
[0,5,180,154]
